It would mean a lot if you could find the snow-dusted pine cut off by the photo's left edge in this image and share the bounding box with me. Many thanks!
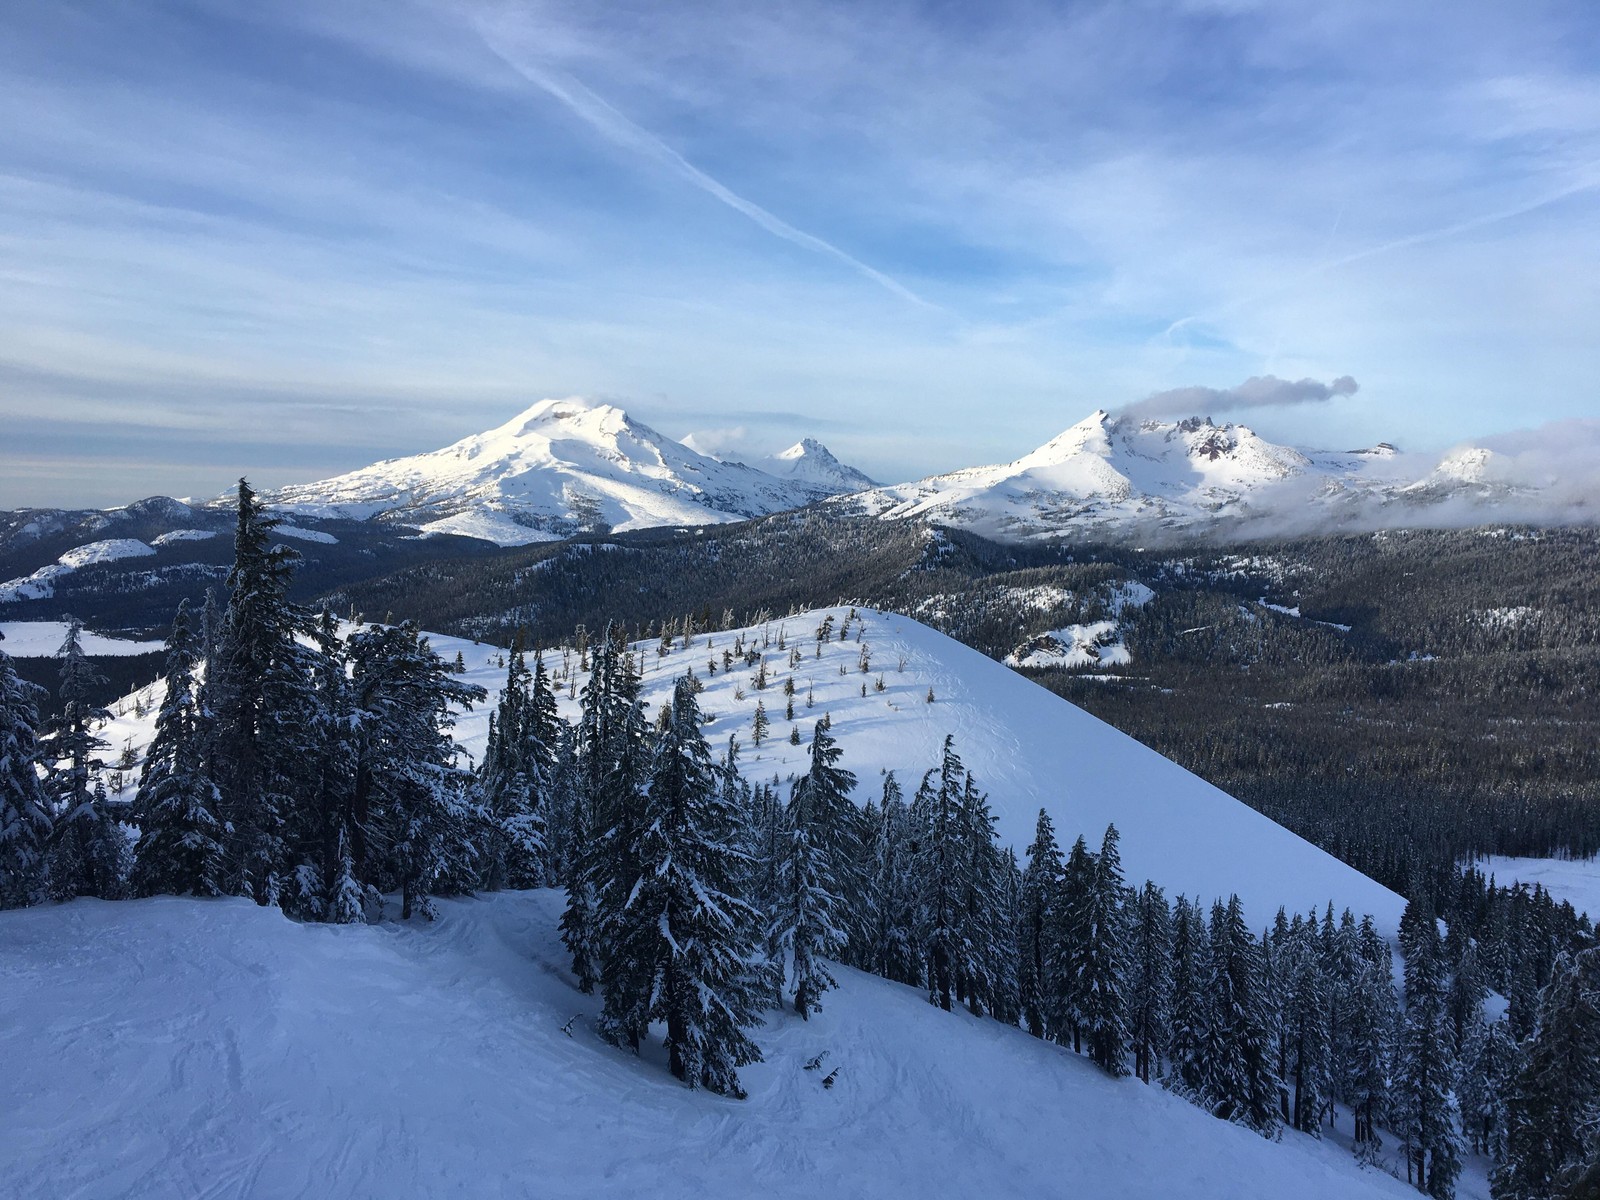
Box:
[0,635,51,909]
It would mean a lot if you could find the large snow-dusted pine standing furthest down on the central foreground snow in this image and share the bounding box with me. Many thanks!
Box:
[616,677,762,1096]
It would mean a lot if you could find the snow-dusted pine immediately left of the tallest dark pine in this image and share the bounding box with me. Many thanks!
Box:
[131,600,227,896]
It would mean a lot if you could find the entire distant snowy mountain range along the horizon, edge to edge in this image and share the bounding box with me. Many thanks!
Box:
[0,398,1600,576]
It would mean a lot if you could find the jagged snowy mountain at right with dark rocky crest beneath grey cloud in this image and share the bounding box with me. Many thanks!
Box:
[843,411,1594,541]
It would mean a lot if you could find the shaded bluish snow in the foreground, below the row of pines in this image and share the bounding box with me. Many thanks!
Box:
[0,891,1414,1200]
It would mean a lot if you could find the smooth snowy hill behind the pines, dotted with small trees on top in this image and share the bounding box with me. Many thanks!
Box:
[101,608,1403,934]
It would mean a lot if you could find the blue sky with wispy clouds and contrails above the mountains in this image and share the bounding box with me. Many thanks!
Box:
[0,0,1600,509]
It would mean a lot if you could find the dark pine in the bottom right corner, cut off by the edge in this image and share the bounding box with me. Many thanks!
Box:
[1493,949,1600,1200]
